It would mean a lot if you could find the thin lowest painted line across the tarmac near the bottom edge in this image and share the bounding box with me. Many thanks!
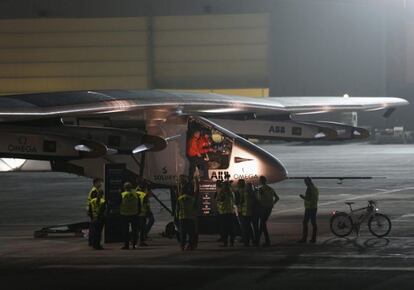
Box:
[38,264,414,272]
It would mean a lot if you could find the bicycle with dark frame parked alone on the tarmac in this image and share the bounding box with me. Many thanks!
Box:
[330,200,391,238]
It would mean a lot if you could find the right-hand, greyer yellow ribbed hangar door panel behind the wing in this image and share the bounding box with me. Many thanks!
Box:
[152,13,269,89]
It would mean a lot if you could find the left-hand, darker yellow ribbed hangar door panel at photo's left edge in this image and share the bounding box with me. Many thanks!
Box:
[0,18,148,94]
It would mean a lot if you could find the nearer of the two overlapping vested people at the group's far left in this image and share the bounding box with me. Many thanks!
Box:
[88,191,106,250]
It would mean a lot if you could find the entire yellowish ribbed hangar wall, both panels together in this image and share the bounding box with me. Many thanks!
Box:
[0,14,269,94]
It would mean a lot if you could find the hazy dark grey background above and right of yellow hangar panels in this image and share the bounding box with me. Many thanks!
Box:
[0,0,414,127]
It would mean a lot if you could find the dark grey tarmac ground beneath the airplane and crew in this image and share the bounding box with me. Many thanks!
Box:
[0,143,414,290]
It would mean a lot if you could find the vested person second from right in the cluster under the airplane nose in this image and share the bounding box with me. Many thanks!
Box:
[237,179,254,247]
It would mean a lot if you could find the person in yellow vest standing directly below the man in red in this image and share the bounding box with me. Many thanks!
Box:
[177,182,197,251]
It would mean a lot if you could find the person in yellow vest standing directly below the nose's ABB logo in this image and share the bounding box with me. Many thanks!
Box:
[216,181,235,247]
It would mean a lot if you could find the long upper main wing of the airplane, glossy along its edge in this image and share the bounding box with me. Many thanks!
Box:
[0,90,408,122]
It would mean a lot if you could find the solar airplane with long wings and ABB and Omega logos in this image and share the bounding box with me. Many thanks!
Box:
[0,90,408,187]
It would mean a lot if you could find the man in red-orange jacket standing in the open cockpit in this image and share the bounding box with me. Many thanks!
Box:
[187,130,208,179]
